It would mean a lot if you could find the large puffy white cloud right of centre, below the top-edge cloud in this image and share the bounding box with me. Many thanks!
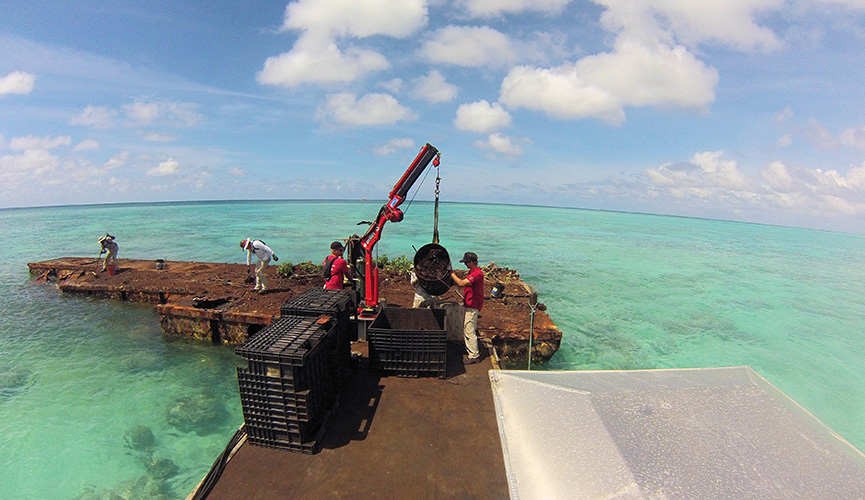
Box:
[499,39,718,124]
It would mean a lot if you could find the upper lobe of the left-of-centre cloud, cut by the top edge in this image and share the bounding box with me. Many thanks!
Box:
[282,0,427,38]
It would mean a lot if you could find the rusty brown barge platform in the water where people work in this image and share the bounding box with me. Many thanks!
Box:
[27,257,562,366]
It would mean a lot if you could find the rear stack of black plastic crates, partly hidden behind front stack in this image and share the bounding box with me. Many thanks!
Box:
[280,288,355,383]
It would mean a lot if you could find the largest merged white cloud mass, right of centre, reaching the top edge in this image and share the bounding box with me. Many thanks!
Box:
[492,0,783,124]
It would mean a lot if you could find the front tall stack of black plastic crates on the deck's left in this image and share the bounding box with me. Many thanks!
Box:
[235,316,338,453]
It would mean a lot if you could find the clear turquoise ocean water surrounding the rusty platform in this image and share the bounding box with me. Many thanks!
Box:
[0,201,865,499]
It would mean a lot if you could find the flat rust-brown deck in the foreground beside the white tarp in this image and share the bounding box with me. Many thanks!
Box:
[201,343,508,500]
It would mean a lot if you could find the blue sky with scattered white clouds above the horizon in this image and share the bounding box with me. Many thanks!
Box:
[0,0,865,234]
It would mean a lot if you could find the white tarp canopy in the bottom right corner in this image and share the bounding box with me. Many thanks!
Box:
[490,367,865,500]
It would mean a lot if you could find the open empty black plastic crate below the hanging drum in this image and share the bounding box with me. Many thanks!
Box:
[367,307,447,378]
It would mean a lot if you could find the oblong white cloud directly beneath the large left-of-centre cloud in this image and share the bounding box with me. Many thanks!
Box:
[316,92,417,126]
